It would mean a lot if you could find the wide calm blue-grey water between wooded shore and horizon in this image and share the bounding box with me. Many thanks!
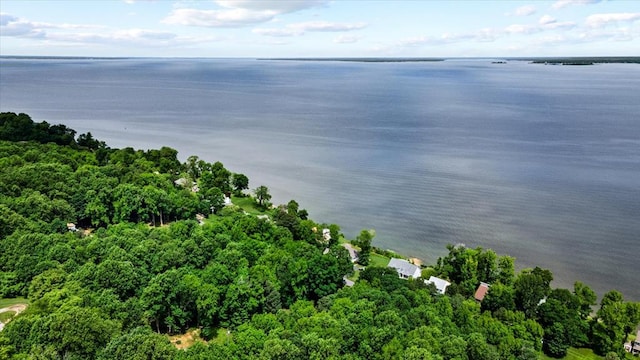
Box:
[0,58,640,301]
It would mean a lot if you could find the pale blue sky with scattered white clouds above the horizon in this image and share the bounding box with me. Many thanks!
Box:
[0,0,640,58]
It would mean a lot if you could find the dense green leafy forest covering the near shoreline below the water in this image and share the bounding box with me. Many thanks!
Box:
[0,112,640,360]
